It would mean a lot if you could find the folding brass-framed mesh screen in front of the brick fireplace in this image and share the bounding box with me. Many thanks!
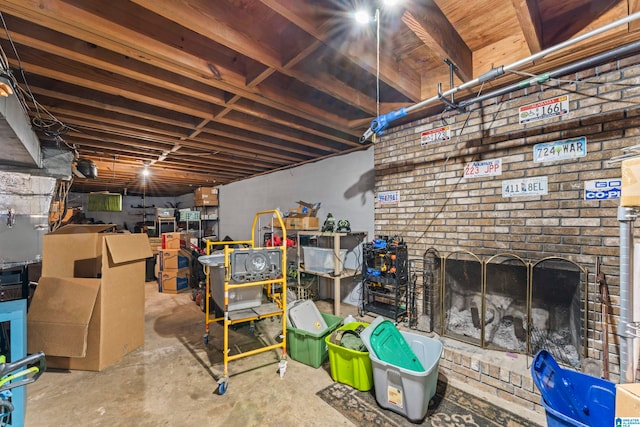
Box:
[438,252,587,366]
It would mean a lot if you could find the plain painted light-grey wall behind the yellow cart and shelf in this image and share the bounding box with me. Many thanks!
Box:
[219,147,375,240]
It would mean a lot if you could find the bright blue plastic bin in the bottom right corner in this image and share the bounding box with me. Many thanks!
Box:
[531,350,616,427]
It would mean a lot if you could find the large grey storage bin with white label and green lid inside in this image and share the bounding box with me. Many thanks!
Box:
[360,319,443,422]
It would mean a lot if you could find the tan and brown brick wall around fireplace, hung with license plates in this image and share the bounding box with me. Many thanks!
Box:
[375,56,640,392]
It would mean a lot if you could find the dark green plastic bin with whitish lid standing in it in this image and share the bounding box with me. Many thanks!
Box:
[287,313,342,368]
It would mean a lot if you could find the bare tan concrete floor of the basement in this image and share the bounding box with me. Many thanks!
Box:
[26,282,544,427]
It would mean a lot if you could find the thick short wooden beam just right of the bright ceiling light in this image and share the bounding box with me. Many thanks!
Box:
[402,0,473,82]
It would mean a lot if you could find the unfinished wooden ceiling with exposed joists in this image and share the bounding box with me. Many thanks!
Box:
[0,0,640,196]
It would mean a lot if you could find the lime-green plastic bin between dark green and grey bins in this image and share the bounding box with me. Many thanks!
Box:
[325,322,373,391]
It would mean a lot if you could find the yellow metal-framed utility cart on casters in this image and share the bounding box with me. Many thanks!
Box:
[201,210,287,394]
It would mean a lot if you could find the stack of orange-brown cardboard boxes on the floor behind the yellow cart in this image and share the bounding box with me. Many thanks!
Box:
[158,232,192,294]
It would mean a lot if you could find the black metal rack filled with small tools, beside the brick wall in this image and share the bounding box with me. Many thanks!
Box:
[360,238,409,321]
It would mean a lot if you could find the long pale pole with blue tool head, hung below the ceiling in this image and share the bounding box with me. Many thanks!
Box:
[360,12,640,144]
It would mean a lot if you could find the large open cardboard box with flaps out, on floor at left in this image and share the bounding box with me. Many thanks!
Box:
[27,225,152,371]
